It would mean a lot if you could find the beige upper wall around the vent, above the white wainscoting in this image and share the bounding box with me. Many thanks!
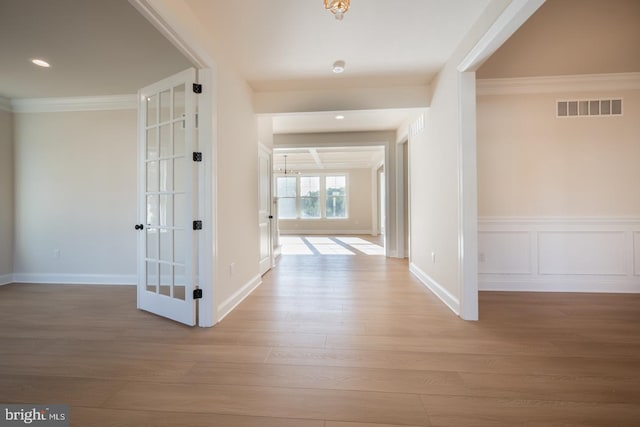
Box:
[478,90,640,217]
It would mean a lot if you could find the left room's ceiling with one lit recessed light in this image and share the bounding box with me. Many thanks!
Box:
[0,0,191,98]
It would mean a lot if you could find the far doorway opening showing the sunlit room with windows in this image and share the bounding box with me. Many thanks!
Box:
[273,145,387,255]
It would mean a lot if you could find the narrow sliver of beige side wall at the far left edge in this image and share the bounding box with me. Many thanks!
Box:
[0,109,14,285]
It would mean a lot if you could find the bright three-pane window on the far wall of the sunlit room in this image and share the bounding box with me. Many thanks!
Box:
[276,175,348,219]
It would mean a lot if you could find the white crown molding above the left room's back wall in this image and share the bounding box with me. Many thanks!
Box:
[10,95,138,113]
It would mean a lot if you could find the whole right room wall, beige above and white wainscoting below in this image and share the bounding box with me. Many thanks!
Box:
[478,85,640,292]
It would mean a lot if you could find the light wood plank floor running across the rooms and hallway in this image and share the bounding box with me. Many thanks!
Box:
[0,242,640,427]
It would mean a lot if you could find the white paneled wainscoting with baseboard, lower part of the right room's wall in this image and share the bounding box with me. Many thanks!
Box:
[478,217,640,292]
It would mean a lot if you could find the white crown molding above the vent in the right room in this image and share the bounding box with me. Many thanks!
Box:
[476,73,640,96]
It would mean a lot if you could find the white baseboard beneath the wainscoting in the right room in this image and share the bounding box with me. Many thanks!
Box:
[478,277,640,294]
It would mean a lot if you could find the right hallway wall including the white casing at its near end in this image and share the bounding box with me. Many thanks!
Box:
[409,1,509,320]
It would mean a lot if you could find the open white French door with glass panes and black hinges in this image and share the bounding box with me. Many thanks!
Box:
[135,68,197,326]
